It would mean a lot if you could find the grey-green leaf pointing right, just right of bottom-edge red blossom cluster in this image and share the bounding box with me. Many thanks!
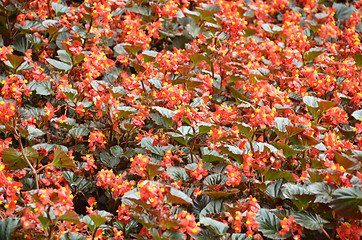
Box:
[292,211,329,230]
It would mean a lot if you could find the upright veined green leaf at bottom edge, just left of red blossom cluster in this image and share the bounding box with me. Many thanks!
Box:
[256,208,288,239]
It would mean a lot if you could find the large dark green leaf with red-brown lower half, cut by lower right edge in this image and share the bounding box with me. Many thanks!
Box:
[331,186,362,219]
